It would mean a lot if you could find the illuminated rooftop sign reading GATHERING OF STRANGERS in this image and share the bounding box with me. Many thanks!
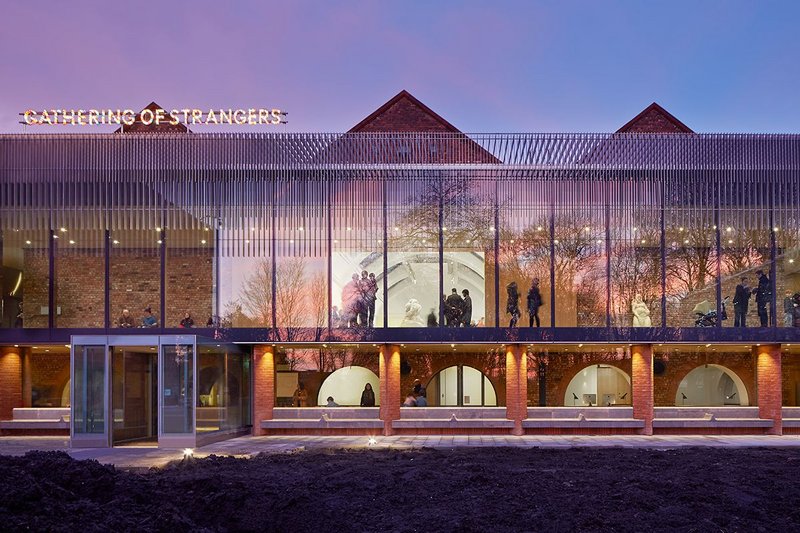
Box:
[20,108,287,126]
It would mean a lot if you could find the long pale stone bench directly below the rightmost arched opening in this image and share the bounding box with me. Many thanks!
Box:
[653,406,773,429]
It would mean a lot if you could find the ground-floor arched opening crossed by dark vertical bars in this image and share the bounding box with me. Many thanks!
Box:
[425,365,497,407]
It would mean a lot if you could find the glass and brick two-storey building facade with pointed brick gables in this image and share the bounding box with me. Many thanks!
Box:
[0,91,800,446]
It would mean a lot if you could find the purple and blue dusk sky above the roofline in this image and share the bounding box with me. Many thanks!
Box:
[0,0,800,132]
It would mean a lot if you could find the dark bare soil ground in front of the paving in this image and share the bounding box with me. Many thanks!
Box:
[0,448,800,533]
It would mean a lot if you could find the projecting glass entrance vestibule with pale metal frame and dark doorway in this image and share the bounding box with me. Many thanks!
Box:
[70,335,251,448]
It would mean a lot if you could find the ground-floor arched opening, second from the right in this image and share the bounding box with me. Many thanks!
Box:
[564,365,631,407]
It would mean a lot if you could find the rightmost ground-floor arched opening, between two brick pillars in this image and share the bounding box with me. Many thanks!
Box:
[675,364,750,407]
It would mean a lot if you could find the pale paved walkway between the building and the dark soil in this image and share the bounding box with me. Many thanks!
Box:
[0,435,800,470]
